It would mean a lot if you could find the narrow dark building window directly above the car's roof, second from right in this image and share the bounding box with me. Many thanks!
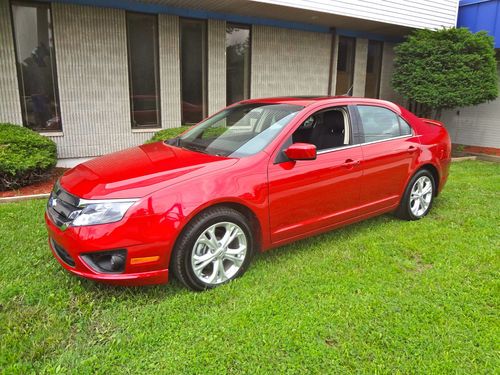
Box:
[335,36,356,95]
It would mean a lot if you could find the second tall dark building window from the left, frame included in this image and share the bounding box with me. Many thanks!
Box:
[127,12,161,129]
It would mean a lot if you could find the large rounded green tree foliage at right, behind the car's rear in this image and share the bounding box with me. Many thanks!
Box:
[392,28,498,117]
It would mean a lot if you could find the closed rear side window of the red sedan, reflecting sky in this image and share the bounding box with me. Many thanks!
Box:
[357,105,411,142]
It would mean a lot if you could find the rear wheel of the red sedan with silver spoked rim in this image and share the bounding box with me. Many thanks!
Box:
[396,169,436,220]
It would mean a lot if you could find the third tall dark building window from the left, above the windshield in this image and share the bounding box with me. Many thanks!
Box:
[180,19,207,124]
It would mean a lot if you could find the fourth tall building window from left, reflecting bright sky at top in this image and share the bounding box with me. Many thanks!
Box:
[226,24,251,105]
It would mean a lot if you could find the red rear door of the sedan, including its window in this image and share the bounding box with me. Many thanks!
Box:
[356,105,420,213]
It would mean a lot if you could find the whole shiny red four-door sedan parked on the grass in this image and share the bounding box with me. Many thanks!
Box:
[46,97,451,290]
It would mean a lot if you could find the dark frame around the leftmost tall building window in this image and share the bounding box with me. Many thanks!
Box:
[8,0,64,134]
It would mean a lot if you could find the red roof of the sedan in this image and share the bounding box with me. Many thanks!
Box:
[239,95,400,112]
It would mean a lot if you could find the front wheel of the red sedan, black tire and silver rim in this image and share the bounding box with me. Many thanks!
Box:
[171,207,254,291]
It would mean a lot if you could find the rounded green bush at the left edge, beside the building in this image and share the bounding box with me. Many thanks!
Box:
[0,124,57,190]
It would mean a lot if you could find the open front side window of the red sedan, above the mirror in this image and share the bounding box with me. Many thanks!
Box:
[292,107,350,151]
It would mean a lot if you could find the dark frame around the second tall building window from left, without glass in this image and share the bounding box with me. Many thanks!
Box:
[125,11,162,130]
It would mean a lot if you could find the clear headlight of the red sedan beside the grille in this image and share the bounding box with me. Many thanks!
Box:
[70,199,135,227]
